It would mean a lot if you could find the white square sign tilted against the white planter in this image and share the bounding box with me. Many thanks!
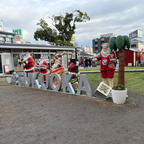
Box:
[97,82,111,96]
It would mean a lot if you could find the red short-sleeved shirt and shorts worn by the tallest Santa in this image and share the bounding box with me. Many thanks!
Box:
[96,52,115,78]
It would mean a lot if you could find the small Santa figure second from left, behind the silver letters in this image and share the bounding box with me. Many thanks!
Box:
[39,56,49,82]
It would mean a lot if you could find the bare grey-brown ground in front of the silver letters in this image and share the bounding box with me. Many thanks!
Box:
[0,81,144,144]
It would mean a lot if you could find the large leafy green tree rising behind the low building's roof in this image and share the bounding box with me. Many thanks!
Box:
[34,10,90,46]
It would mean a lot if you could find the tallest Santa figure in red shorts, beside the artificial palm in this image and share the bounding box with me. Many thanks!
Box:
[93,43,116,87]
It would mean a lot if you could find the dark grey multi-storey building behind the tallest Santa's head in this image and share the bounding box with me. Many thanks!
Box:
[92,33,116,54]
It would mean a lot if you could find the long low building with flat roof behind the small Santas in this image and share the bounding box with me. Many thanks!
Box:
[0,43,78,74]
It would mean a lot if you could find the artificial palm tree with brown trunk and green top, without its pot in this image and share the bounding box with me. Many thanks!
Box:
[109,35,130,87]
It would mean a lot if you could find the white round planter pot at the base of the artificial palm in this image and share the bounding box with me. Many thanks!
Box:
[112,89,127,104]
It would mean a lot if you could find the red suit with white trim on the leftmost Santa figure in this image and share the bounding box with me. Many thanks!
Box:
[23,55,35,73]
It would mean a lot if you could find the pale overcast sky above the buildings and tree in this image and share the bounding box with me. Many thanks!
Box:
[0,0,144,46]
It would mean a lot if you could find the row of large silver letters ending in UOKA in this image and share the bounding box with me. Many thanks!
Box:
[11,72,92,97]
